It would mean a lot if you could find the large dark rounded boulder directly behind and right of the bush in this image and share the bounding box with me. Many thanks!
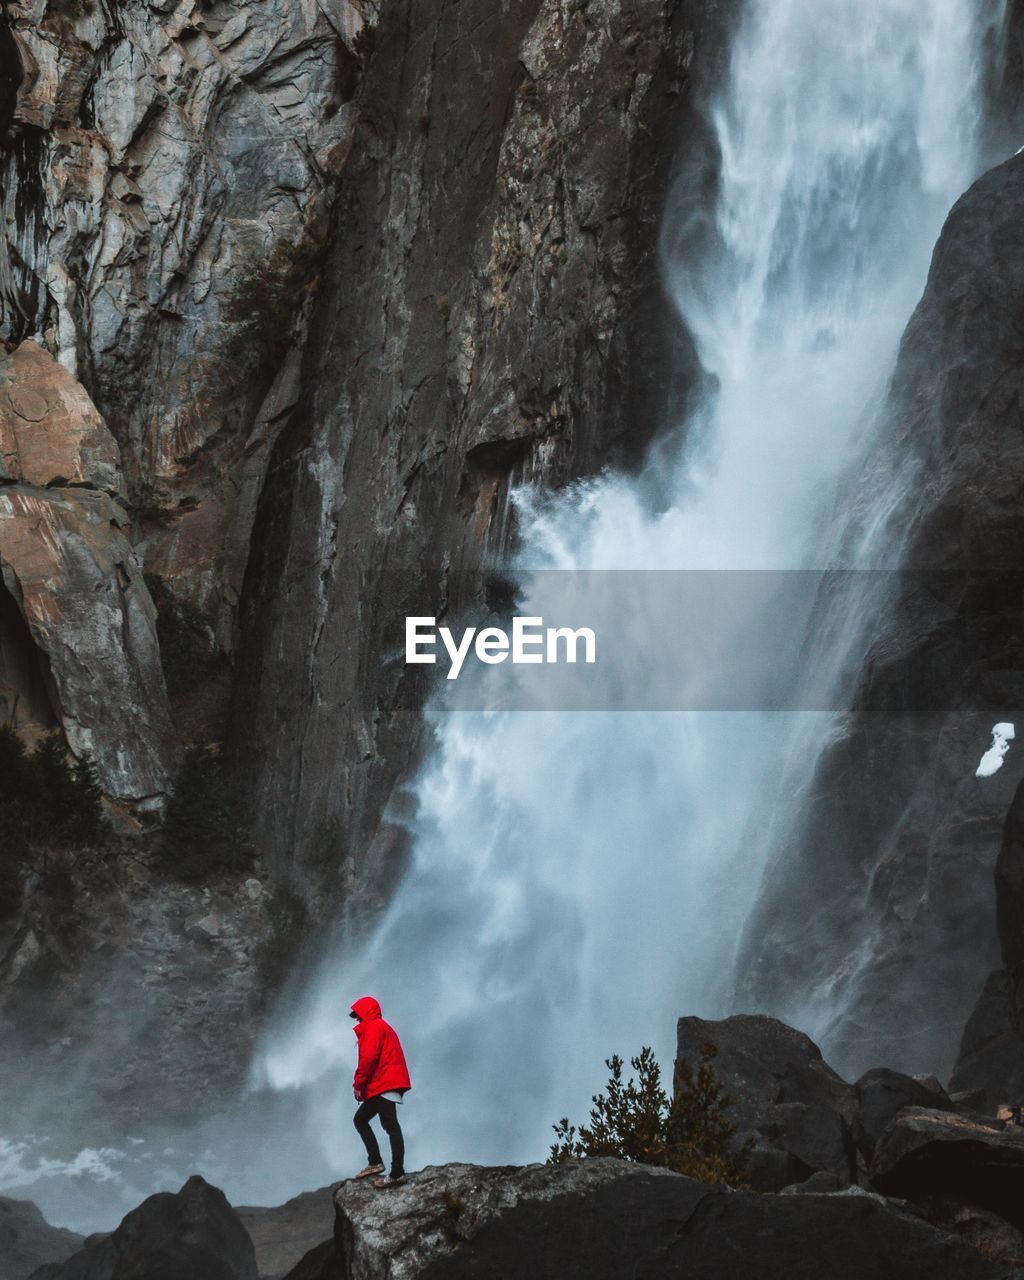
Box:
[676,1014,858,1190]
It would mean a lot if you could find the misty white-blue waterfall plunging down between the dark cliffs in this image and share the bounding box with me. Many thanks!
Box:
[256,0,998,1167]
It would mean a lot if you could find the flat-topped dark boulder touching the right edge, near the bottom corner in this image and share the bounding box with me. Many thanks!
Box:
[870,1107,1024,1231]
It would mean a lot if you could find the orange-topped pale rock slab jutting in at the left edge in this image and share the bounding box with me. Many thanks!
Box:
[0,342,174,803]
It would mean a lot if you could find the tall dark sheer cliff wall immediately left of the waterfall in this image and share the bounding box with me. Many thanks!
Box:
[234,0,732,885]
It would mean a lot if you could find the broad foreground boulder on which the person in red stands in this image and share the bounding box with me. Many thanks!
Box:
[330,1158,1005,1280]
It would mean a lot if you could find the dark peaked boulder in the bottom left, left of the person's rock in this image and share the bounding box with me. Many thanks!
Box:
[33,1176,257,1280]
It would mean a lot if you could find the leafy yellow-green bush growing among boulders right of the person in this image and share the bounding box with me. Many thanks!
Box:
[549,1044,751,1187]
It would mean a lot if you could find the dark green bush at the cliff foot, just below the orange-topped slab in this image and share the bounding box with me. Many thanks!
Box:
[160,746,253,881]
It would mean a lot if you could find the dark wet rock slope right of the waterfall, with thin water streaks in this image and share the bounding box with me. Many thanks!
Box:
[741,147,1024,1075]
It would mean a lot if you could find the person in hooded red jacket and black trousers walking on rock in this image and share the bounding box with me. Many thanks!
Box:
[348,996,411,1187]
